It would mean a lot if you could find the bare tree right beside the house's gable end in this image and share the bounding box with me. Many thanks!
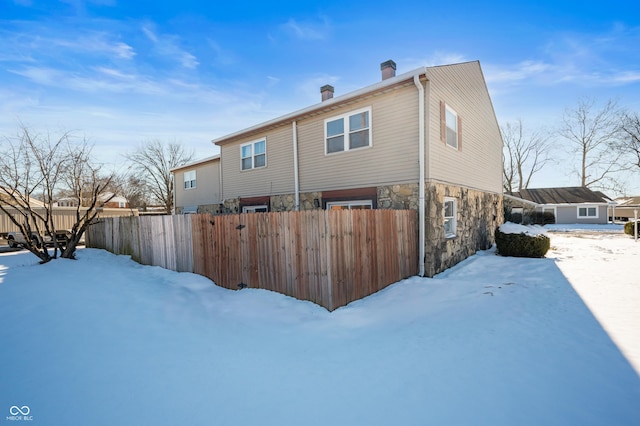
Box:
[500,120,552,192]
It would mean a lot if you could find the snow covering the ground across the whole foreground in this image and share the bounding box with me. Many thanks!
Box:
[0,227,640,425]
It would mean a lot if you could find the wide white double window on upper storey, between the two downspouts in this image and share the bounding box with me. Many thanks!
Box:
[324,108,371,154]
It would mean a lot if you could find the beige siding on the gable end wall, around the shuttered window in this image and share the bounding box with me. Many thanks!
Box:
[428,62,502,192]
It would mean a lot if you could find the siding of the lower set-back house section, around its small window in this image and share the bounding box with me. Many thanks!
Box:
[173,159,222,207]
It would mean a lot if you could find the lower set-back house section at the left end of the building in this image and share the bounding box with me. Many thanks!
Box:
[171,155,223,214]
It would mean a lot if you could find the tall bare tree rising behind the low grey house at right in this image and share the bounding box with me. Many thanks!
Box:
[560,99,628,188]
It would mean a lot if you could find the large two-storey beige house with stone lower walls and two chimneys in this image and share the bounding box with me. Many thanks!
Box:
[198,61,502,276]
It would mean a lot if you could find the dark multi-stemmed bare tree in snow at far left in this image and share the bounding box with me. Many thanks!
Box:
[0,124,116,263]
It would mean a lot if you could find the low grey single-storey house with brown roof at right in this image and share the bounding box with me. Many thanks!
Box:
[506,186,614,224]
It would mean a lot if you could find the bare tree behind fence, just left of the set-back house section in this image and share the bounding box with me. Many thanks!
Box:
[126,140,193,214]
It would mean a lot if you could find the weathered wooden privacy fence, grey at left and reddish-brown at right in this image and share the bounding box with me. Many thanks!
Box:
[86,210,418,310]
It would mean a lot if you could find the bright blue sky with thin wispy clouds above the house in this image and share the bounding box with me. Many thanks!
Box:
[0,0,640,193]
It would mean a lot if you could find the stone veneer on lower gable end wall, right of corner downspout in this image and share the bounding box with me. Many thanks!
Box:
[425,183,503,277]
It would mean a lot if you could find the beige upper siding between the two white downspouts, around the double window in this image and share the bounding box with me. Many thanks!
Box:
[298,85,419,192]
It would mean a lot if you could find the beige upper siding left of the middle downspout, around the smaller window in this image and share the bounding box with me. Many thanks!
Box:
[220,124,294,199]
